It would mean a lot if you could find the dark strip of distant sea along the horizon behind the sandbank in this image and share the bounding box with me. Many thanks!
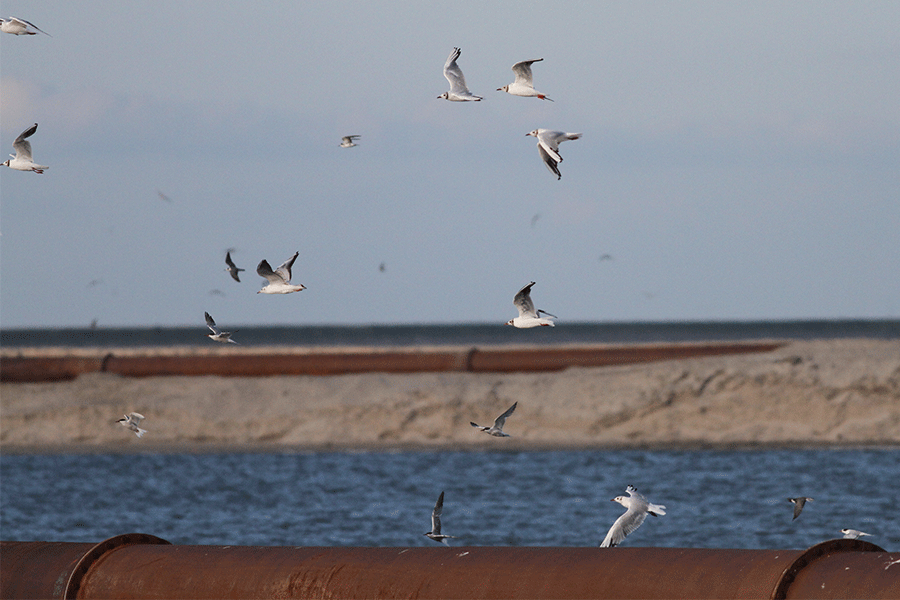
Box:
[0,319,900,347]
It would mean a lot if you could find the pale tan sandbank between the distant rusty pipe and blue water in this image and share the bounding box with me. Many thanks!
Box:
[0,339,900,452]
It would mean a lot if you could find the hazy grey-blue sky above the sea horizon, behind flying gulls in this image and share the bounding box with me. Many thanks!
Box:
[0,0,900,329]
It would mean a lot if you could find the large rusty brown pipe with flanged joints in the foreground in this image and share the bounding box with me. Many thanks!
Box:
[0,534,900,599]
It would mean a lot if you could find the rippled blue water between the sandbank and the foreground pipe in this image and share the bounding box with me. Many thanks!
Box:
[0,449,900,551]
